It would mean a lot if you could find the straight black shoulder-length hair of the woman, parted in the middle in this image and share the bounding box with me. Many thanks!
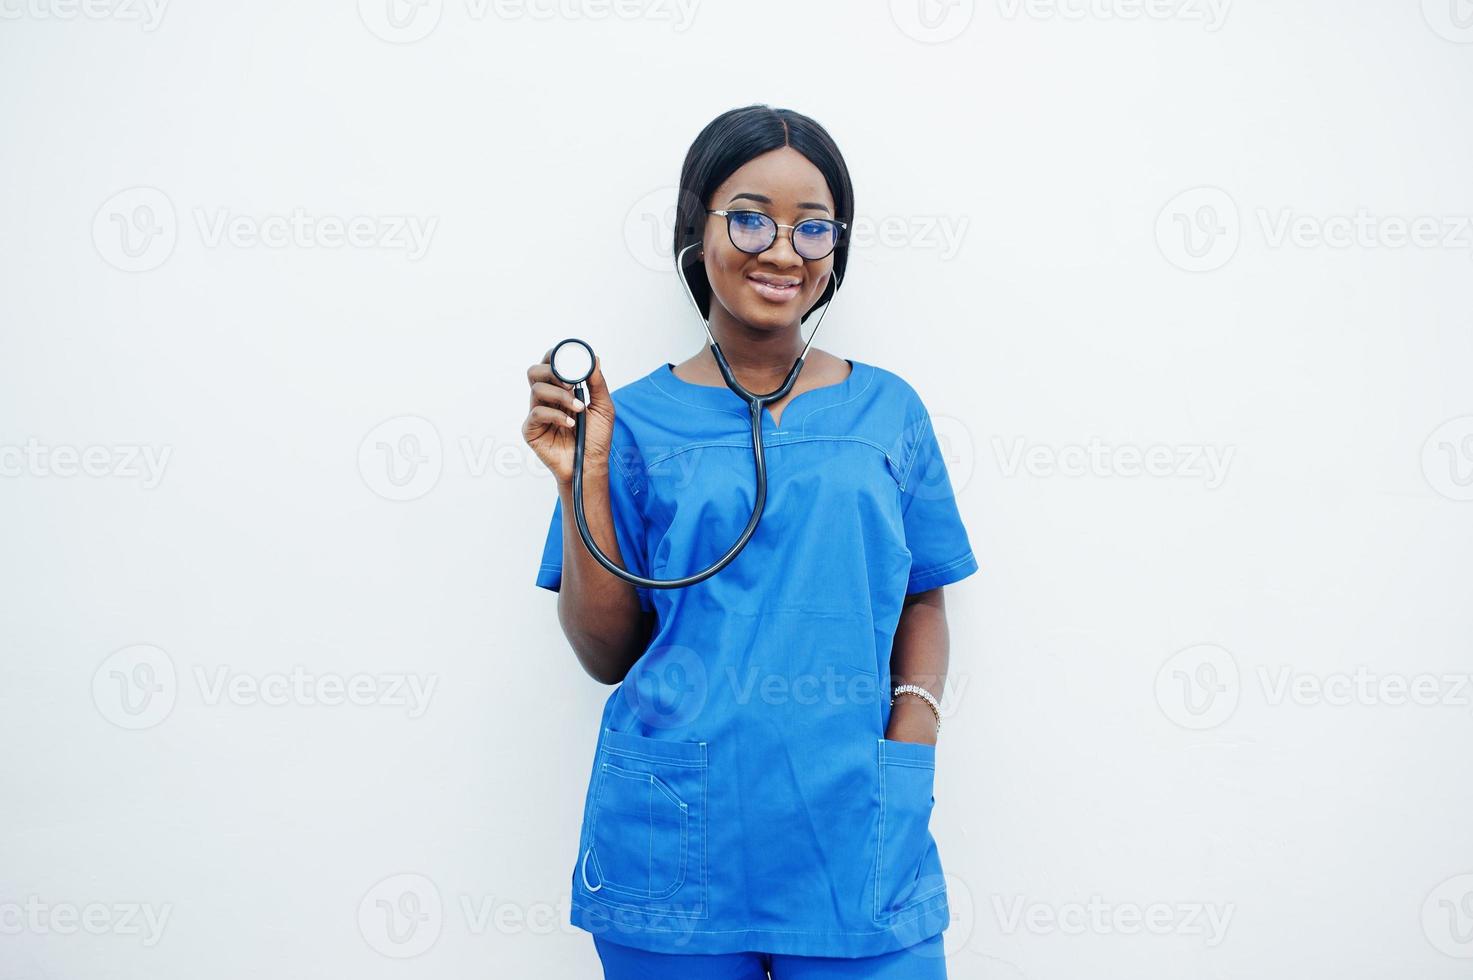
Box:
[675,105,854,323]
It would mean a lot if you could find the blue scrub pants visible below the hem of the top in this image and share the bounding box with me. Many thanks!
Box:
[594,933,946,980]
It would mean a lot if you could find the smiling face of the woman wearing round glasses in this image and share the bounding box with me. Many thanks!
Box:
[701,146,837,330]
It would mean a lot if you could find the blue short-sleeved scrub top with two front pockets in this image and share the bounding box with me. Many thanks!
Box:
[536,360,978,956]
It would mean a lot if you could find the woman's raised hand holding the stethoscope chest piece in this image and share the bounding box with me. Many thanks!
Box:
[521,348,614,486]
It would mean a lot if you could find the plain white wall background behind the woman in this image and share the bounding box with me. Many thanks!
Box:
[0,0,1473,980]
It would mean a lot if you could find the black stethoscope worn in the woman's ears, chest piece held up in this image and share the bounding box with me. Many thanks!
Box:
[549,242,840,588]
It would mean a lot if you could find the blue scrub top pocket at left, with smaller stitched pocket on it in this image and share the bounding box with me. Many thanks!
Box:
[579,728,707,917]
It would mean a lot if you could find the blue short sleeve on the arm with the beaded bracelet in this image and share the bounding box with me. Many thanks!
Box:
[900,405,978,595]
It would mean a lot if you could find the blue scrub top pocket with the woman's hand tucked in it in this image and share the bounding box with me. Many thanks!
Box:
[873,738,946,925]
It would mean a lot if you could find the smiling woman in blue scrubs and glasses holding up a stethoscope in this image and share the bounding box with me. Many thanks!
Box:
[523,106,978,980]
